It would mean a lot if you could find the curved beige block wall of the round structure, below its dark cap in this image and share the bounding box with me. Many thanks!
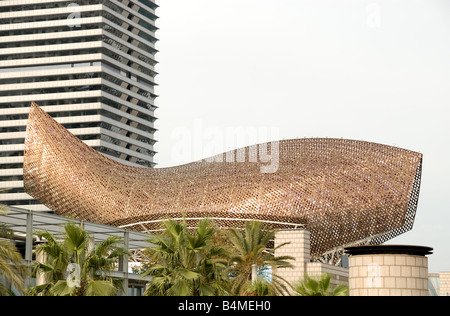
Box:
[349,254,428,296]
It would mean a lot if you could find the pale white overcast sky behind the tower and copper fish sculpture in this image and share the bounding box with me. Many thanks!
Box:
[152,0,450,272]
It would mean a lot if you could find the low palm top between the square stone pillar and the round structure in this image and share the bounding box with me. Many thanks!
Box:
[293,273,349,296]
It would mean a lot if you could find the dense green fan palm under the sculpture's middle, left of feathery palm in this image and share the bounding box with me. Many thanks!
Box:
[143,219,229,296]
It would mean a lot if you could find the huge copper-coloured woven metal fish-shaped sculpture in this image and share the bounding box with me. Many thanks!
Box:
[23,104,422,258]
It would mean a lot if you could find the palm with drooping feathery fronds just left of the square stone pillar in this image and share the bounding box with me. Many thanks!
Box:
[225,221,294,295]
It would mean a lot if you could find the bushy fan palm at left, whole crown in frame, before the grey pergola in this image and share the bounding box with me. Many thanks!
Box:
[29,223,128,296]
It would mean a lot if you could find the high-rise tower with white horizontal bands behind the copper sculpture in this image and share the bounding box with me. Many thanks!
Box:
[0,0,158,211]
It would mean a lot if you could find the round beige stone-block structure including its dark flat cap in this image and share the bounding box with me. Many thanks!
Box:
[345,245,433,296]
